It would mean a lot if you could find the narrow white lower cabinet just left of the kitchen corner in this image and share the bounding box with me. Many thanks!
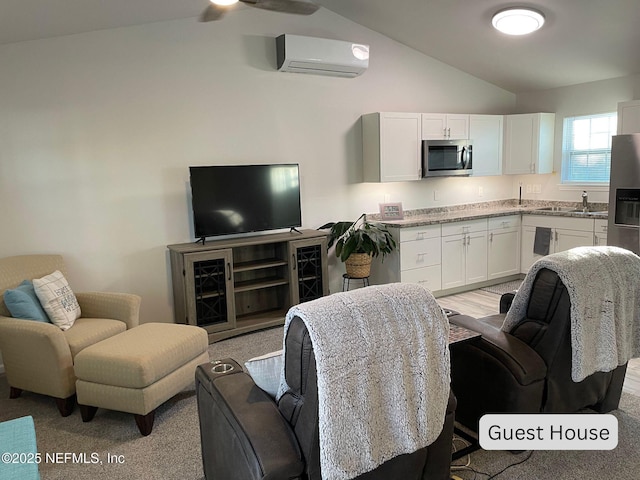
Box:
[487,215,520,280]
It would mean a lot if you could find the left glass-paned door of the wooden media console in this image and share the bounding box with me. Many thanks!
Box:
[184,249,235,332]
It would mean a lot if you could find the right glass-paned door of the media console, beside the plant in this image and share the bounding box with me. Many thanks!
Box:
[289,238,329,305]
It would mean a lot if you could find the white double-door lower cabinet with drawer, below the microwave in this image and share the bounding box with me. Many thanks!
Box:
[442,219,487,290]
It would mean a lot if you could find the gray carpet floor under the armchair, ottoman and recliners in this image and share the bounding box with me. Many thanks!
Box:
[0,327,640,480]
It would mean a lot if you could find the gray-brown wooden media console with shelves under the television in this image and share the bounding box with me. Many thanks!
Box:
[167,230,329,343]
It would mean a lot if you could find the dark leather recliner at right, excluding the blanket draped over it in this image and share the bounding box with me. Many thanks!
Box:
[450,269,627,431]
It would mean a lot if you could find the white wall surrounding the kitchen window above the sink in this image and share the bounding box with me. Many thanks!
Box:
[514,75,640,202]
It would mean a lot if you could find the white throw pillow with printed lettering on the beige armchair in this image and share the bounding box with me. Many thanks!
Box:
[33,270,80,330]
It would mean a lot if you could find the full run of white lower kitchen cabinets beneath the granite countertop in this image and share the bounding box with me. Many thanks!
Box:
[370,214,607,295]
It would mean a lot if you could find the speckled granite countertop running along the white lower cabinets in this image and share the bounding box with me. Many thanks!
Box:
[367,200,608,228]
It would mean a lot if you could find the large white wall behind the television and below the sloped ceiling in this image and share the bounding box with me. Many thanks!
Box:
[0,8,515,322]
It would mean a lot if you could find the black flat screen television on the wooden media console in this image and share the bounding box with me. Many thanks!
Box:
[189,164,302,243]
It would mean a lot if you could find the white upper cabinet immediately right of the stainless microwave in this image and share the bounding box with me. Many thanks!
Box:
[468,115,504,177]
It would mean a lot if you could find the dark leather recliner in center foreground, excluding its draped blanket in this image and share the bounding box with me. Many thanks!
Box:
[196,317,456,480]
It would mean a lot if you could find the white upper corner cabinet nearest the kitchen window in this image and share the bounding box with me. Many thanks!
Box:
[504,113,555,175]
